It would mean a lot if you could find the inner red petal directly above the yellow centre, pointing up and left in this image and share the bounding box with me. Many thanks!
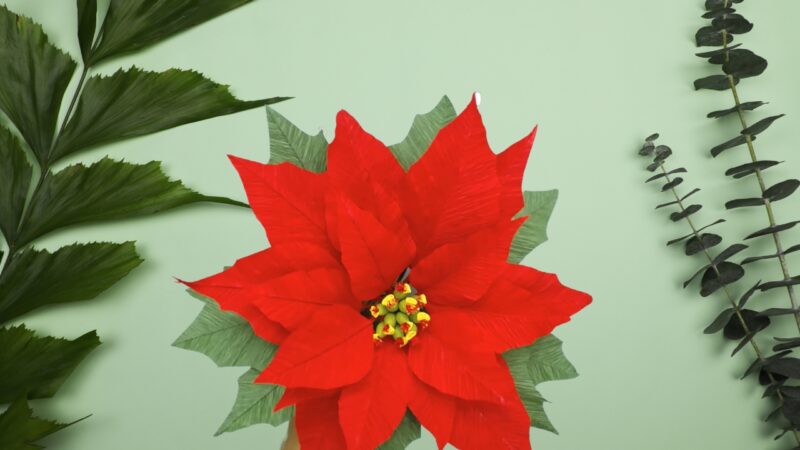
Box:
[337,197,415,300]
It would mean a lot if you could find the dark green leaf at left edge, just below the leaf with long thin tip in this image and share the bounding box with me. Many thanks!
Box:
[0,242,142,324]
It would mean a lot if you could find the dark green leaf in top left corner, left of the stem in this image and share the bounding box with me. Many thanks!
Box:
[0,5,76,162]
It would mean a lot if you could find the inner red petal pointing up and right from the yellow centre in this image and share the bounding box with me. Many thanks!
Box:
[409,219,524,305]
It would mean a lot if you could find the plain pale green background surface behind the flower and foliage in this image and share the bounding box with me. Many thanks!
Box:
[0,0,800,450]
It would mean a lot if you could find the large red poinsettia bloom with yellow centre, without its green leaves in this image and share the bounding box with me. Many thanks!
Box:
[187,98,590,450]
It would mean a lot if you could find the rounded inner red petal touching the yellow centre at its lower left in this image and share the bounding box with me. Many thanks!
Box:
[256,305,375,389]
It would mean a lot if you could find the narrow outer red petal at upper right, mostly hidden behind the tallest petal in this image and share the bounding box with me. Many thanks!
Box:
[497,128,536,217]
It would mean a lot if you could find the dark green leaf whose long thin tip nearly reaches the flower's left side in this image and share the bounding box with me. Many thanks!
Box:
[15,158,243,245]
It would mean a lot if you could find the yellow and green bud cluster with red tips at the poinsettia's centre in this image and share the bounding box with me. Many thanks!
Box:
[367,283,431,347]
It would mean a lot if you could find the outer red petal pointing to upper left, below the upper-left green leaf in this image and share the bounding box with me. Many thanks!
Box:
[230,156,328,245]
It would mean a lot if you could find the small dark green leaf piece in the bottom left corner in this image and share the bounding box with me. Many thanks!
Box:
[0,398,69,450]
